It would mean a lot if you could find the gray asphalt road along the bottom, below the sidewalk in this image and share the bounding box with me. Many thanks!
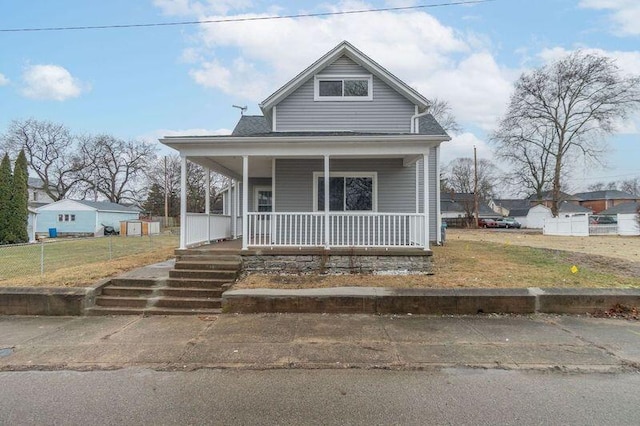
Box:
[0,369,640,425]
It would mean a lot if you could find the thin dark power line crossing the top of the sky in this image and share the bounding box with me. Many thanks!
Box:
[0,0,496,33]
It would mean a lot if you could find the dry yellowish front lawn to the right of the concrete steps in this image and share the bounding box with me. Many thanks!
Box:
[234,230,640,288]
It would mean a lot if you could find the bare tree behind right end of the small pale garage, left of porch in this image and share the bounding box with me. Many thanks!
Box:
[78,135,156,204]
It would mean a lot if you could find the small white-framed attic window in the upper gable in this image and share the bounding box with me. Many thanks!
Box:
[314,75,373,101]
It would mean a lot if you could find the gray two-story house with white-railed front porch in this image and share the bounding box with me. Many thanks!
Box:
[160,42,450,250]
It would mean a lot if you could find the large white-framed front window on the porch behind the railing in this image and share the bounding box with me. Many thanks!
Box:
[314,173,377,211]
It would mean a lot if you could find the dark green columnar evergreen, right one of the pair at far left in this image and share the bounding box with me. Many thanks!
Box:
[9,151,29,243]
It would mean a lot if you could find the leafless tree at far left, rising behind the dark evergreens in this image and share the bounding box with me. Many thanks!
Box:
[1,119,85,201]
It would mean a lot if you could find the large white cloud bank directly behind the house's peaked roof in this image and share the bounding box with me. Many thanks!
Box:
[166,1,517,129]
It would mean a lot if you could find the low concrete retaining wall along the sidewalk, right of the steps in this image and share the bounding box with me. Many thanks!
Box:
[222,287,640,315]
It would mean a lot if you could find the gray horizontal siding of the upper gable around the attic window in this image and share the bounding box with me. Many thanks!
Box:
[276,57,415,133]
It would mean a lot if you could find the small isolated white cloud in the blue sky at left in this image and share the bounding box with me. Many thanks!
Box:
[22,65,88,101]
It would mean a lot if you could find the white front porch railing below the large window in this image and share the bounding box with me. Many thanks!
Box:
[247,212,425,247]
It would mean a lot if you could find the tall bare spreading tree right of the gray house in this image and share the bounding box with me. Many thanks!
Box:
[494,51,640,216]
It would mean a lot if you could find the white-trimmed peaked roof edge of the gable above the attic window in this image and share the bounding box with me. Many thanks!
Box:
[260,41,430,117]
